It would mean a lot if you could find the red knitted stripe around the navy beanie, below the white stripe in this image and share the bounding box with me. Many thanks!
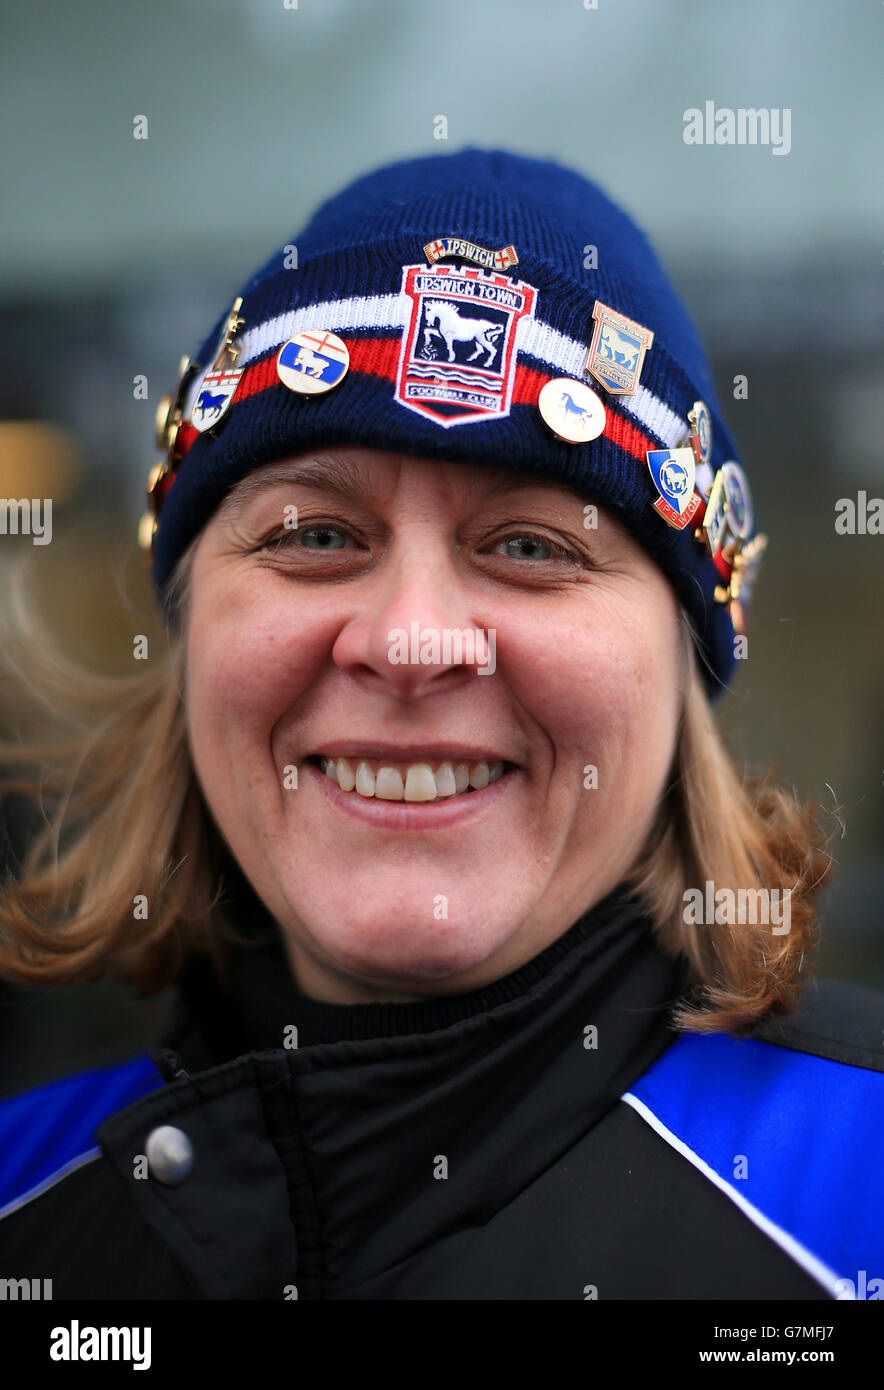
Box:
[175,335,656,464]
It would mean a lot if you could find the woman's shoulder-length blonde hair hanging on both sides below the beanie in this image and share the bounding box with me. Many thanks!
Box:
[0,542,831,1033]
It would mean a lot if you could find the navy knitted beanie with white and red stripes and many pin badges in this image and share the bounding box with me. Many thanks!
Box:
[140,149,763,694]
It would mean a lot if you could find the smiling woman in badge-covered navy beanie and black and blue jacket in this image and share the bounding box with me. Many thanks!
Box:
[0,149,884,1300]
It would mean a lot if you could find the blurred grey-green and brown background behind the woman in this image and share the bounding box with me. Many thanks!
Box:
[0,0,884,1091]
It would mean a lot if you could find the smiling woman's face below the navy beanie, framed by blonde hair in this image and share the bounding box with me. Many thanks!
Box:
[188,448,681,1002]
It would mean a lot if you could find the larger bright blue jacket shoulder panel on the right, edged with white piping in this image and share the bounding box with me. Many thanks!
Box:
[627,1034,884,1297]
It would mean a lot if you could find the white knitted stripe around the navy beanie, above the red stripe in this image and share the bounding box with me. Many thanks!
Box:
[230,295,691,449]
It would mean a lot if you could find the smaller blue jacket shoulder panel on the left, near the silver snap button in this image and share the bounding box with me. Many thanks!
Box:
[0,1052,165,1215]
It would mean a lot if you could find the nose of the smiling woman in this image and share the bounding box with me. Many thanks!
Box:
[332,530,493,701]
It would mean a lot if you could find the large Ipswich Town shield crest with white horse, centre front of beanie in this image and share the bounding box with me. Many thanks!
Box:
[393,265,537,430]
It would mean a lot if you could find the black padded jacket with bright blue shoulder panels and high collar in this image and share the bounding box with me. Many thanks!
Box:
[0,894,884,1300]
